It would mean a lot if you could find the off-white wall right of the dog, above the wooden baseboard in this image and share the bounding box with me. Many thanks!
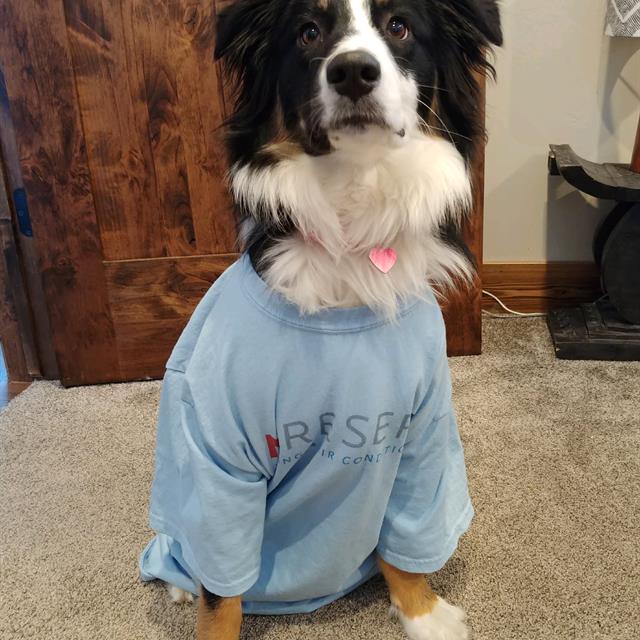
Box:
[484,0,640,262]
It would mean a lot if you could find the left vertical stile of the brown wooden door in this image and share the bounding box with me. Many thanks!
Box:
[0,0,120,384]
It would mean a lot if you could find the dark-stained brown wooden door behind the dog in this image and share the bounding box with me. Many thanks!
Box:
[0,0,481,385]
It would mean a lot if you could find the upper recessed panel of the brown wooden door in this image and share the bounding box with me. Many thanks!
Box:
[65,0,235,260]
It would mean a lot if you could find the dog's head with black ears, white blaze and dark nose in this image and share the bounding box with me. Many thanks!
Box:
[215,0,502,164]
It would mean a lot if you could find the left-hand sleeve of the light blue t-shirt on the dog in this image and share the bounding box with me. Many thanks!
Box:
[151,372,267,596]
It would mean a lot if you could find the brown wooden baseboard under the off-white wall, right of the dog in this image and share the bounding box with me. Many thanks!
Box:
[482,262,602,313]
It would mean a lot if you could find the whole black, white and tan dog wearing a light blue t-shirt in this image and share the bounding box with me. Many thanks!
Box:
[140,0,502,640]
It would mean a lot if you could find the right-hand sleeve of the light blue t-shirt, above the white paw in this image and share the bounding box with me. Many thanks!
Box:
[378,346,473,573]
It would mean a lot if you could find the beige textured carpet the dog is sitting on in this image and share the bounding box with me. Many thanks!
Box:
[0,319,640,640]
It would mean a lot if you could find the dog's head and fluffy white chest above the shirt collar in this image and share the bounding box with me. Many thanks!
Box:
[215,0,502,317]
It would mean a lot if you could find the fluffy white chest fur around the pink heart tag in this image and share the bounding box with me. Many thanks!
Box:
[231,131,471,317]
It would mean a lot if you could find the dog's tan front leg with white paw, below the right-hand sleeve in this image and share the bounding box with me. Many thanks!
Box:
[378,557,469,640]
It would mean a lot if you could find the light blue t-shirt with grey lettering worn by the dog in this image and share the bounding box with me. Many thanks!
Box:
[140,255,473,614]
